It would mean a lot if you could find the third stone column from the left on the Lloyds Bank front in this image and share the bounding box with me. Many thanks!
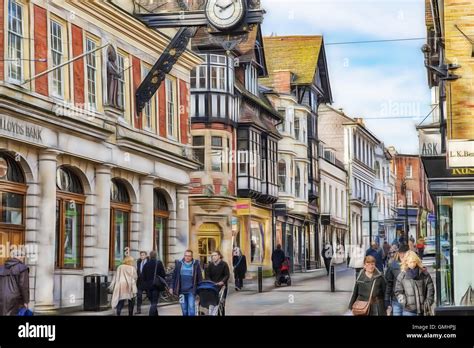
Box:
[138,177,154,253]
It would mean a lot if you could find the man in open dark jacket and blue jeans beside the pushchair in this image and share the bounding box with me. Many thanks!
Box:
[170,250,202,316]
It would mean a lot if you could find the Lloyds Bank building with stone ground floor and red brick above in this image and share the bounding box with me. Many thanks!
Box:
[0,0,201,314]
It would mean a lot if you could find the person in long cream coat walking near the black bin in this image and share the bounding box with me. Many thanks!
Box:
[109,256,138,316]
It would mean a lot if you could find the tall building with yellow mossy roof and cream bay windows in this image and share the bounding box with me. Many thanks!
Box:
[261,36,332,271]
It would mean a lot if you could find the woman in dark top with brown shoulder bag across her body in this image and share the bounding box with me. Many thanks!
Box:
[349,256,386,316]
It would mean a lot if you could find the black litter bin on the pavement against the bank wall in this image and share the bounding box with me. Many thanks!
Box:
[84,274,108,312]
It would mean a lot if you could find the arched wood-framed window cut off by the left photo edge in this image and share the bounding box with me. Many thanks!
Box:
[0,152,26,265]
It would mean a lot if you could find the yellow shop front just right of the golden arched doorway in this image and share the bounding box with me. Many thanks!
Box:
[234,199,273,276]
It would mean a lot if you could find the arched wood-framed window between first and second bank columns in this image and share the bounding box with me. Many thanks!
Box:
[55,166,85,269]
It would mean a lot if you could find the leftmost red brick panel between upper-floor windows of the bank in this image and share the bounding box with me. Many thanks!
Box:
[34,5,48,96]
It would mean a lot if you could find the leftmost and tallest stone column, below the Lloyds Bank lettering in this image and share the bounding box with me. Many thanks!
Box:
[35,149,58,314]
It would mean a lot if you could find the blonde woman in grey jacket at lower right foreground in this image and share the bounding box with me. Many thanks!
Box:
[395,250,434,316]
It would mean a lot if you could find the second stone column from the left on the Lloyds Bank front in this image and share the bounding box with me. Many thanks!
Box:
[94,165,112,275]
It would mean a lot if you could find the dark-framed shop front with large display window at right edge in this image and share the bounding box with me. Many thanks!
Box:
[423,157,474,315]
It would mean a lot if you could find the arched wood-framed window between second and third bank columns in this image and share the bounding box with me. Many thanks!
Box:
[109,179,132,270]
